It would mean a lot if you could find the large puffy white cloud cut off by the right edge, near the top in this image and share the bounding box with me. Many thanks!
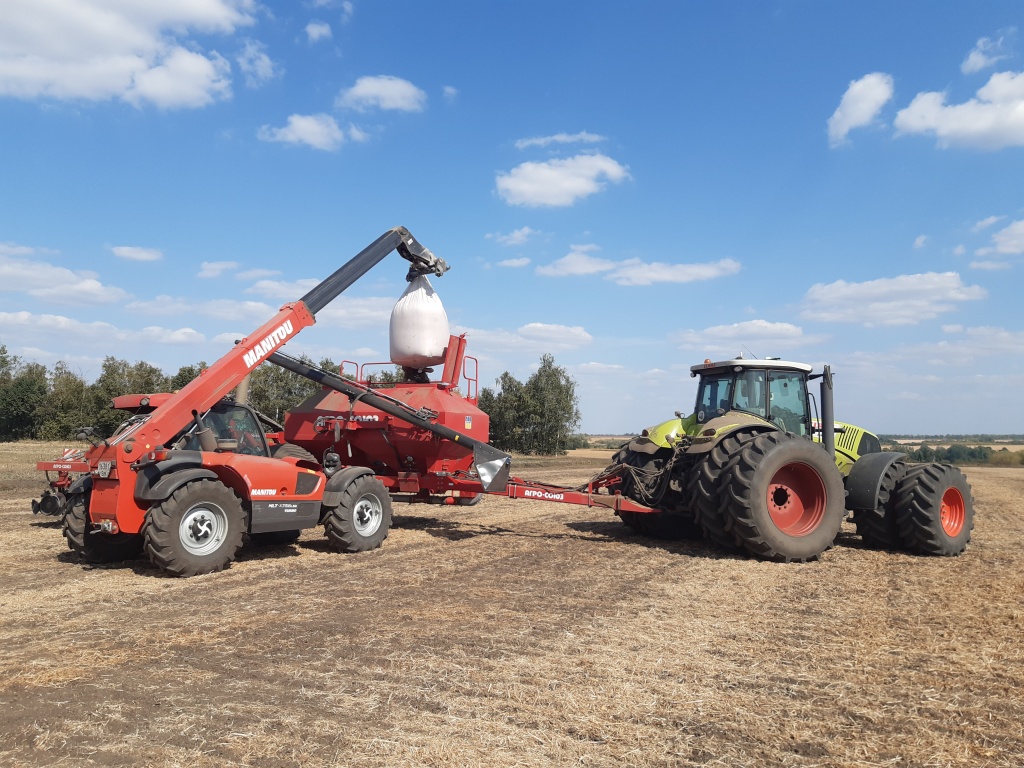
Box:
[894,72,1024,150]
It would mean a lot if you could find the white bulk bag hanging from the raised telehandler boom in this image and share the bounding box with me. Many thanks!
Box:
[390,274,450,368]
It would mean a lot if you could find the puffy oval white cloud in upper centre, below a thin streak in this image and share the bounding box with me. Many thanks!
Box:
[496,155,630,208]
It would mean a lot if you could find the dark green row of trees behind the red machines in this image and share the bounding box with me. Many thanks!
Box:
[0,344,586,455]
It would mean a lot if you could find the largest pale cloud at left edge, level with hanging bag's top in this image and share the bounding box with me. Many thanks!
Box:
[0,254,130,306]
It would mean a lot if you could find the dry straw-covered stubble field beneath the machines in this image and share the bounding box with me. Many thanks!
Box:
[0,443,1024,768]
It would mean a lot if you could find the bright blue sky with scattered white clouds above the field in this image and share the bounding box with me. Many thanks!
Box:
[0,0,1024,433]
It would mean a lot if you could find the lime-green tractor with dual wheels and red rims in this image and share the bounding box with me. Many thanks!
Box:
[607,357,974,562]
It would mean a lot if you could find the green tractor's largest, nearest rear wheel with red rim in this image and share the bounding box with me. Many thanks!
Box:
[721,432,846,562]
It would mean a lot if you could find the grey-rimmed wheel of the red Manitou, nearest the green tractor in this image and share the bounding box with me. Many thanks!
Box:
[324,475,391,552]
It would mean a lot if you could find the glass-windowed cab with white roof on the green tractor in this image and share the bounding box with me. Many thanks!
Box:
[690,358,811,436]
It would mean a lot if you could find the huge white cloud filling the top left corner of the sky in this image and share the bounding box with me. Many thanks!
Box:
[0,0,256,109]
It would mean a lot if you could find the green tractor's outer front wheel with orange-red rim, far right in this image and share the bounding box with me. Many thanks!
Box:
[895,464,974,557]
